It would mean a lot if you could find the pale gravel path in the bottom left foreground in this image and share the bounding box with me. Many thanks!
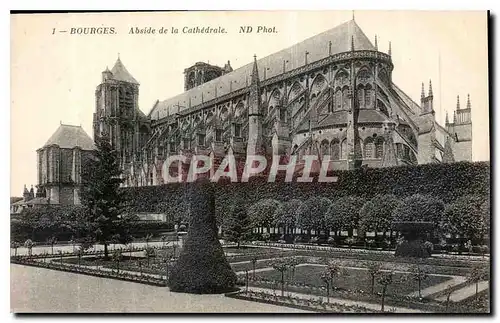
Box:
[10,265,306,313]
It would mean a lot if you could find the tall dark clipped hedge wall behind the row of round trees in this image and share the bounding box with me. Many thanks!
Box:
[123,162,490,216]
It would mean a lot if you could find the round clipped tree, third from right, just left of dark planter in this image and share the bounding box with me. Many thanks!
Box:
[359,194,400,238]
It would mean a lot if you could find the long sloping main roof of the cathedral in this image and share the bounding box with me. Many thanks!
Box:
[149,20,375,120]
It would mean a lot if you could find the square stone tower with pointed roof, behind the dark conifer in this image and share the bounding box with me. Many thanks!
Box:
[94,57,149,163]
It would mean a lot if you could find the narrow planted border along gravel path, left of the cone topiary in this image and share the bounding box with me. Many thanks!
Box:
[11,259,167,287]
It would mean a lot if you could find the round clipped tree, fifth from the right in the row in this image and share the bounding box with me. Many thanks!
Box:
[297,196,331,234]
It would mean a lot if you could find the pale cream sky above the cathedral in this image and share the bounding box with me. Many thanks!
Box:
[10,11,490,196]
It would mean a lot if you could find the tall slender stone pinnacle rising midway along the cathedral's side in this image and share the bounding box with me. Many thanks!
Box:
[247,55,262,156]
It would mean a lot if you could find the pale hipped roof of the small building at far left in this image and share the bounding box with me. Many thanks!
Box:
[44,124,95,150]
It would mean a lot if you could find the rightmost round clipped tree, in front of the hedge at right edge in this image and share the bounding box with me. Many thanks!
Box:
[443,195,489,241]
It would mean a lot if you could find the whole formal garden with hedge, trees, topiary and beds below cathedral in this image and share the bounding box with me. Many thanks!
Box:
[11,141,490,313]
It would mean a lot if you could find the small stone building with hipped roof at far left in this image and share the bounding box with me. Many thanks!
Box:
[37,123,95,205]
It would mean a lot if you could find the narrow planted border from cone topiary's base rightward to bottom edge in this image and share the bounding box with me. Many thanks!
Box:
[226,291,378,313]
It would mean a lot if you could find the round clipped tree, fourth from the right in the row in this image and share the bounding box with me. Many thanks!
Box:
[326,196,365,237]
